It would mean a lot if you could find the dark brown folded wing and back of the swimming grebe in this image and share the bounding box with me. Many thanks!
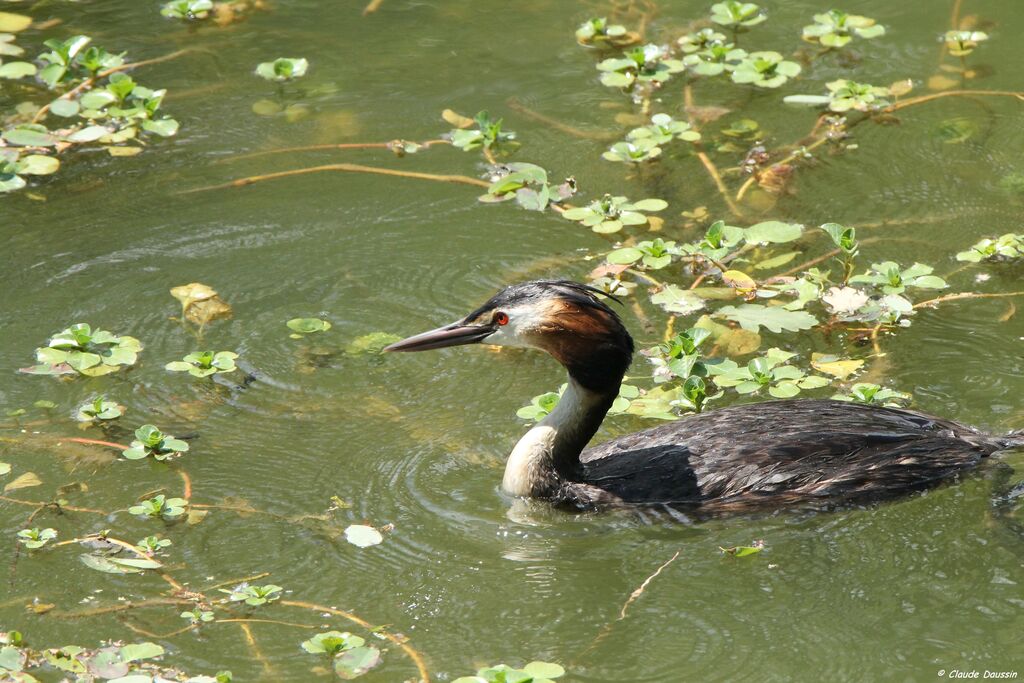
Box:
[578,400,1000,504]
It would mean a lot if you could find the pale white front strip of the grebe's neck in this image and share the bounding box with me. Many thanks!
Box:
[502,378,595,496]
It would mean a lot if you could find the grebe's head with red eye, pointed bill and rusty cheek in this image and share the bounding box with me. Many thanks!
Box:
[384,280,633,392]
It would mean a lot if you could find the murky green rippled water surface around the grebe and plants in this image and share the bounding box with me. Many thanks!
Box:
[0,0,1024,682]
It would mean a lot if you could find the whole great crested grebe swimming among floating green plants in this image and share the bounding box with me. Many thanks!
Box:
[384,281,1024,512]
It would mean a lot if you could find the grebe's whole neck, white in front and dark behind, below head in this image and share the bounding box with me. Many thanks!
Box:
[502,374,622,498]
